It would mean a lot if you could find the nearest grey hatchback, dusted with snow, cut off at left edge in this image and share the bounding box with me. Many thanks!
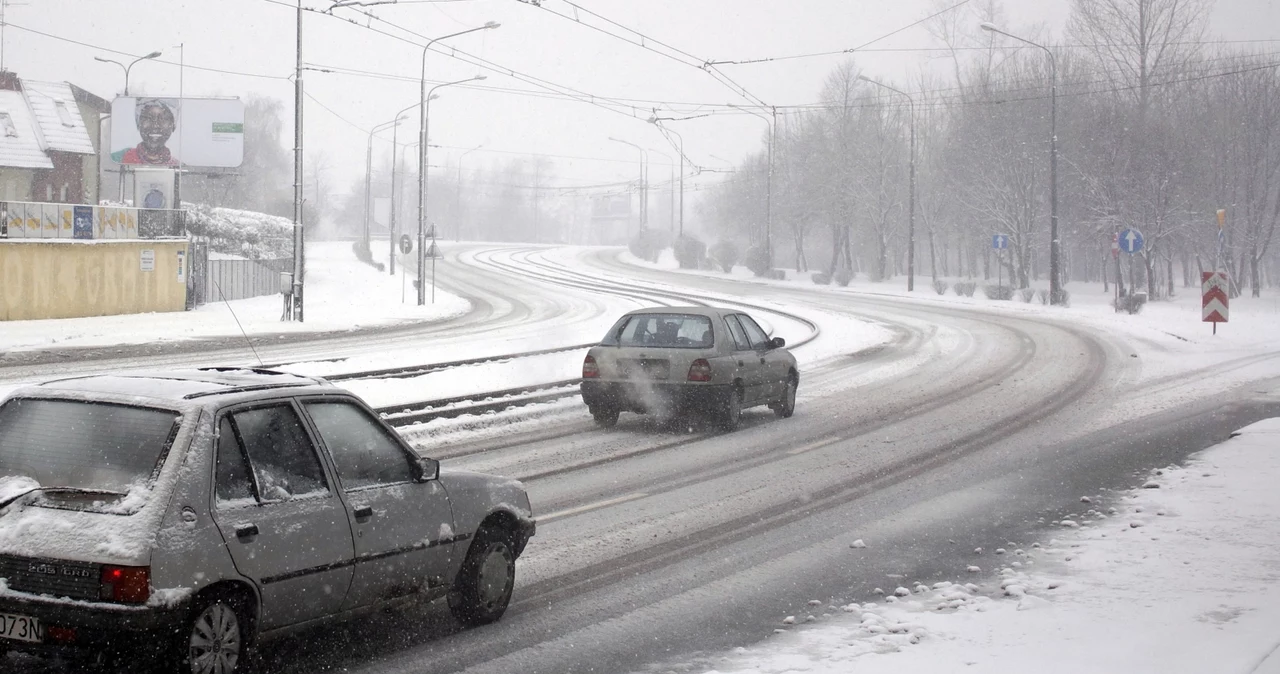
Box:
[0,370,535,674]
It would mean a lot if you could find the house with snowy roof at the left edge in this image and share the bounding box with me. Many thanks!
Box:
[0,72,110,203]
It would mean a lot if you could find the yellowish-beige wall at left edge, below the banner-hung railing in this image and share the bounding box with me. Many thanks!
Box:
[0,239,189,321]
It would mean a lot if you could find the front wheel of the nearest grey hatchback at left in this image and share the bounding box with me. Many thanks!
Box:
[449,528,516,627]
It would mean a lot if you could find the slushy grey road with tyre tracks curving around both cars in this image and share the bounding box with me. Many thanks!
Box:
[5,247,1280,674]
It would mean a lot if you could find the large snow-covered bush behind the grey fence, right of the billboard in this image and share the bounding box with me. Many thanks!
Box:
[183,203,293,260]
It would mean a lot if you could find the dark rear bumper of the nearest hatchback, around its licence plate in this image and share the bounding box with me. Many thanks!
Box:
[0,591,187,654]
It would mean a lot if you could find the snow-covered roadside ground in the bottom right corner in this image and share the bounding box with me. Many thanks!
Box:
[681,419,1280,674]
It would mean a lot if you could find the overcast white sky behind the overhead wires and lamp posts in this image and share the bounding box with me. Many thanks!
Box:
[4,0,1280,198]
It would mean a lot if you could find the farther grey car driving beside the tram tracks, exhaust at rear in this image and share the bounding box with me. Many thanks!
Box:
[581,307,800,430]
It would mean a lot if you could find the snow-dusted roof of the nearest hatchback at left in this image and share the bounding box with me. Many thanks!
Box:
[14,368,337,405]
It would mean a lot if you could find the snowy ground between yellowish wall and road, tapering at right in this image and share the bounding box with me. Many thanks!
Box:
[0,242,471,352]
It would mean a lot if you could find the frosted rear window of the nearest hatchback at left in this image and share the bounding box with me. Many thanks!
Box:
[0,398,179,494]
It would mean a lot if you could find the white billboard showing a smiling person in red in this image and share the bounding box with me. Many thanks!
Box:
[111,97,244,168]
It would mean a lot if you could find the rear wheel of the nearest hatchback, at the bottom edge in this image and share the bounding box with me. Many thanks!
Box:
[177,595,248,674]
